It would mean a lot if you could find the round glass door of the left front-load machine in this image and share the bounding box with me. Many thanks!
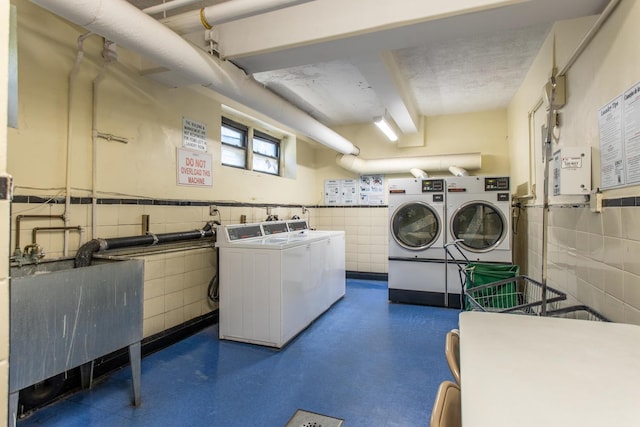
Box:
[389,202,442,251]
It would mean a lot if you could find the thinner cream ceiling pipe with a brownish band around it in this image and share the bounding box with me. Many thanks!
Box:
[161,0,311,34]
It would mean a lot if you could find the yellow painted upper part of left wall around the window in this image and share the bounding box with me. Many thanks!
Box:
[8,2,315,204]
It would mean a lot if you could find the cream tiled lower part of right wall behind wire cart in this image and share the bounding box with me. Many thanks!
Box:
[516,206,640,325]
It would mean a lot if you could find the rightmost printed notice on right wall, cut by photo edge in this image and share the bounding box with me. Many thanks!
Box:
[623,83,640,184]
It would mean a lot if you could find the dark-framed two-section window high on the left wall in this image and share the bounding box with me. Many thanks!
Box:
[221,117,281,176]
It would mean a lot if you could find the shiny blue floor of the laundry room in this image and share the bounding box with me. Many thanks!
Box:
[18,279,458,427]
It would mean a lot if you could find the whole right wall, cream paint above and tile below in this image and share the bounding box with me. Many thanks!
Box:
[508,0,640,324]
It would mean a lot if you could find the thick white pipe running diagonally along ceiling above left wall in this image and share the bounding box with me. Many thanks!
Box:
[32,0,360,157]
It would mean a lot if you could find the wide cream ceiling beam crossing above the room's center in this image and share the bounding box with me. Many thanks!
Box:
[217,0,529,59]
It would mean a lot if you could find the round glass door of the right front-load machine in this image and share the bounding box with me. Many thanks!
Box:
[449,201,509,252]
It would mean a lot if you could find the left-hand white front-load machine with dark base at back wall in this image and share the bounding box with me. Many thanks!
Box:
[388,178,459,307]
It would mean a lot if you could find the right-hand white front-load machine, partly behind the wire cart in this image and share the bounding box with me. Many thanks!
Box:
[447,176,512,263]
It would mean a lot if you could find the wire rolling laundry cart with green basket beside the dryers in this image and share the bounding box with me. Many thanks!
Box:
[444,240,567,316]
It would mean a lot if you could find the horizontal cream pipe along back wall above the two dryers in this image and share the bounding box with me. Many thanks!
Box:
[336,153,482,175]
